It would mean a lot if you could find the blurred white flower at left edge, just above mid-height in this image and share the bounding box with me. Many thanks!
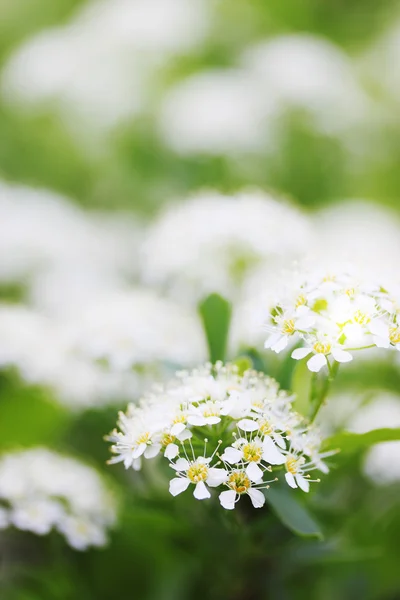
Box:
[0,183,139,296]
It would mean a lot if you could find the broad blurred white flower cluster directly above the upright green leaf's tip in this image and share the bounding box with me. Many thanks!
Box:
[141,191,311,297]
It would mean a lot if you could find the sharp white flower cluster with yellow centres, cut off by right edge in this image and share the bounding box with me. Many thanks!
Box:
[265,274,400,372]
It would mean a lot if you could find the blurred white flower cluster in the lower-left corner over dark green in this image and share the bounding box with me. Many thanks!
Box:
[0,448,116,550]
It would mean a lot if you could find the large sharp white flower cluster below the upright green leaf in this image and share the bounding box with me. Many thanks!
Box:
[107,363,328,509]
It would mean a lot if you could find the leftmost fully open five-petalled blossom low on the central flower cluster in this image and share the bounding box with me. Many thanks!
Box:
[169,456,227,500]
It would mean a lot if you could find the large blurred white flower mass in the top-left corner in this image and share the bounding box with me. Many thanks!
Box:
[3,0,209,134]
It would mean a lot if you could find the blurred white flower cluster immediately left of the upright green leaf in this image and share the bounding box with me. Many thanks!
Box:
[71,288,206,370]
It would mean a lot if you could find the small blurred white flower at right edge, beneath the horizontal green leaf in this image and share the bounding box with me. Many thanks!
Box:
[363,441,400,485]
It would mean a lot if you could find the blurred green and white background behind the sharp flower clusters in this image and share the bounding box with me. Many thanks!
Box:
[0,0,400,600]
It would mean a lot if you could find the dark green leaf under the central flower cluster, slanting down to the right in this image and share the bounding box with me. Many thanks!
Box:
[265,486,323,540]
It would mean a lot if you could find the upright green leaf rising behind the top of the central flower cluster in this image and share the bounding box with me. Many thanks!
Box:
[199,294,232,363]
